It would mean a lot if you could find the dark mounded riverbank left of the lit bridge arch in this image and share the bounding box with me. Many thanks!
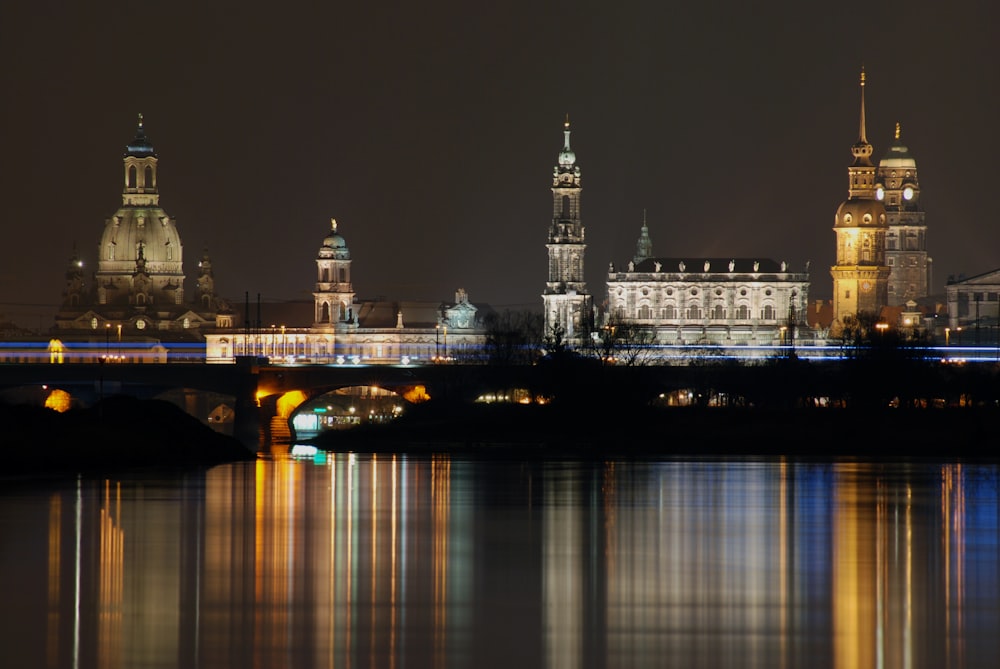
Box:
[0,396,256,476]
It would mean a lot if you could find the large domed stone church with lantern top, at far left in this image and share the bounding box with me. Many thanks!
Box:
[56,114,232,354]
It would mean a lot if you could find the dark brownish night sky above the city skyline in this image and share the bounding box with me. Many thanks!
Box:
[0,0,1000,327]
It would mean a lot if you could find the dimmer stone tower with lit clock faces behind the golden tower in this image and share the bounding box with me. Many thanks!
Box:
[875,123,932,306]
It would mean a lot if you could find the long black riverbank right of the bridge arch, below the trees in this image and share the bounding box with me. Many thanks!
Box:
[311,396,1000,459]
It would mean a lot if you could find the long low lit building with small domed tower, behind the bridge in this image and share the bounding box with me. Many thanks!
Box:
[206,219,492,365]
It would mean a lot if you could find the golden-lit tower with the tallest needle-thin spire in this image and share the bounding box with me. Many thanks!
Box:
[830,69,889,330]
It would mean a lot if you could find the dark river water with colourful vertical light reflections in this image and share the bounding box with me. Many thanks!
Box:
[0,454,1000,669]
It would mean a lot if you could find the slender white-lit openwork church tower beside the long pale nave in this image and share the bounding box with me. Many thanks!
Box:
[542,114,591,344]
